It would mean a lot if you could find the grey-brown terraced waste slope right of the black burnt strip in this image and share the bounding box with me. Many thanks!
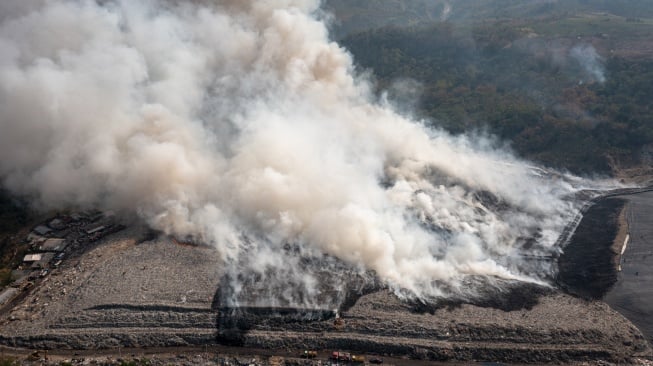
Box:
[227,292,649,363]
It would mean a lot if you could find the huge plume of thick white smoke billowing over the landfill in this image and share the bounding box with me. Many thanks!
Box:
[0,0,600,302]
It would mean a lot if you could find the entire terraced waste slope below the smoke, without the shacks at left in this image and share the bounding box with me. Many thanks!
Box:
[0,228,651,363]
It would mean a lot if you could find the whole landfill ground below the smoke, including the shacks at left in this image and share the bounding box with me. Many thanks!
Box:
[0,204,651,365]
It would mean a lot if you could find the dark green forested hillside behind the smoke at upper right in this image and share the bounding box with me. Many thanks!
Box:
[334,5,653,177]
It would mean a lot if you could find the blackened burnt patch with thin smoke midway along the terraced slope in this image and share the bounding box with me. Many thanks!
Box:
[211,262,383,346]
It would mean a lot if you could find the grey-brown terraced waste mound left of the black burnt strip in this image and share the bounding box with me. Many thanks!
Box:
[2,229,221,349]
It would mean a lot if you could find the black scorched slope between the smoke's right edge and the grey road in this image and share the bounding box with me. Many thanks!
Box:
[556,198,626,299]
